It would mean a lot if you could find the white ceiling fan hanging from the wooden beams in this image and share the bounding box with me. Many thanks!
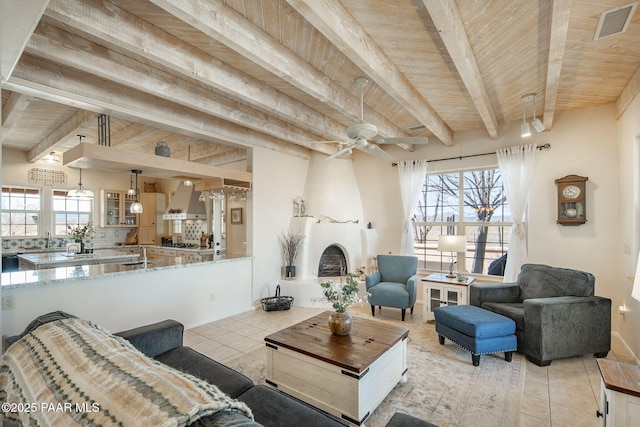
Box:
[325,77,429,161]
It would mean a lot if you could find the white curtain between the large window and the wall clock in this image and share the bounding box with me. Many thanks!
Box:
[497,144,538,282]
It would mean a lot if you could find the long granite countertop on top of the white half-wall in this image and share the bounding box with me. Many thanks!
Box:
[1,254,252,289]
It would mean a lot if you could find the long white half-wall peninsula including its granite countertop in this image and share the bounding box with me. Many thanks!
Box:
[1,254,254,342]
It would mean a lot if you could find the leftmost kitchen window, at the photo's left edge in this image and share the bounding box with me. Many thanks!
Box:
[2,187,41,237]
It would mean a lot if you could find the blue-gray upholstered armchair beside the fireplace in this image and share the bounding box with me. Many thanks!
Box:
[365,255,418,322]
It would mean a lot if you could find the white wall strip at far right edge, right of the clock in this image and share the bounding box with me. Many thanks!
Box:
[613,95,640,358]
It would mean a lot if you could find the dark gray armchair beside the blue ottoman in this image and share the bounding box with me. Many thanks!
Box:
[469,264,611,366]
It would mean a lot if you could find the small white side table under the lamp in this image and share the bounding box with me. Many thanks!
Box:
[422,273,476,323]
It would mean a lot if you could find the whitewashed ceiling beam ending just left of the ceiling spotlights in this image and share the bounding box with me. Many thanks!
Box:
[422,0,498,139]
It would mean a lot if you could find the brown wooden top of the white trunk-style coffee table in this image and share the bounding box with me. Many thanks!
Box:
[264,311,409,373]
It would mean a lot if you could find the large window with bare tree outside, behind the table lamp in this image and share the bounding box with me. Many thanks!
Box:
[413,169,512,274]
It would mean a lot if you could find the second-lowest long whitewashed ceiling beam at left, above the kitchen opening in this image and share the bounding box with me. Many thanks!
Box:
[26,25,317,152]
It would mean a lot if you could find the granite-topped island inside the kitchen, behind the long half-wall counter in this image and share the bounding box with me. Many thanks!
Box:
[18,249,140,270]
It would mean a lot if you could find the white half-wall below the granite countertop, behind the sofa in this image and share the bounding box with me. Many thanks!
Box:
[2,258,252,335]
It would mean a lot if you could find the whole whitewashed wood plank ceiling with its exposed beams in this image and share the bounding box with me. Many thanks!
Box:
[2,0,640,165]
